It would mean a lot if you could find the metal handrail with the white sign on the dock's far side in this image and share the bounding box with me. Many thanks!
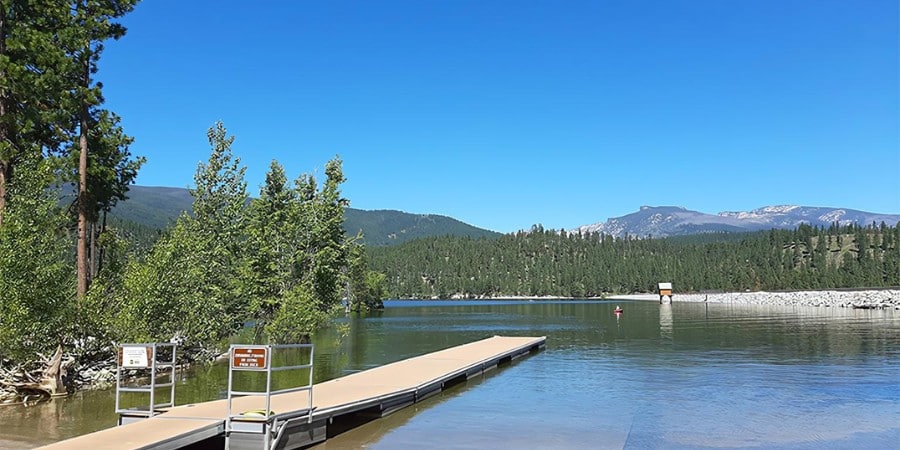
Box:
[116,342,177,417]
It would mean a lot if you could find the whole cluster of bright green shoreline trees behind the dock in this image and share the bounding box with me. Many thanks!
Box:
[102,123,354,347]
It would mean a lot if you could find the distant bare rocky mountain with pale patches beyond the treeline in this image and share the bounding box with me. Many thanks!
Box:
[568,205,900,238]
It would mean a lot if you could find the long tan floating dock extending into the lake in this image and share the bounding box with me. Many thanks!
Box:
[42,336,546,450]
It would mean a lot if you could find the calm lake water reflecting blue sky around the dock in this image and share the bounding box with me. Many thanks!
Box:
[0,298,900,449]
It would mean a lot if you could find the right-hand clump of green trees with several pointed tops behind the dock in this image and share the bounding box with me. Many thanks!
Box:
[243,158,355,340]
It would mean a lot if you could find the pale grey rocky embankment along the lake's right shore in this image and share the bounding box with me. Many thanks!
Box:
[674,289,900,310]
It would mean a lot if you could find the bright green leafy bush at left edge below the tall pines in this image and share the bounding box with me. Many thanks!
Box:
[0,159,76,358]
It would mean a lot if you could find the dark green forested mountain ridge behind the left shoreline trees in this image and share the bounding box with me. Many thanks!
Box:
[112,186,500,245]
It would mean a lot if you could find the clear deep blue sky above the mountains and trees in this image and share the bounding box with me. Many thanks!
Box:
[98,0,900,232]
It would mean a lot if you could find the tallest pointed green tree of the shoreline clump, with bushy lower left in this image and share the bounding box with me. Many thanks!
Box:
[110,122,247,345]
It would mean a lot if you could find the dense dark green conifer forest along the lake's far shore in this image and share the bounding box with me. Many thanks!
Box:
[368,224,900,298]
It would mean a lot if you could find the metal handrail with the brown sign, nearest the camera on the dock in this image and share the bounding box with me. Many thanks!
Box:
[225,344,315,448]
